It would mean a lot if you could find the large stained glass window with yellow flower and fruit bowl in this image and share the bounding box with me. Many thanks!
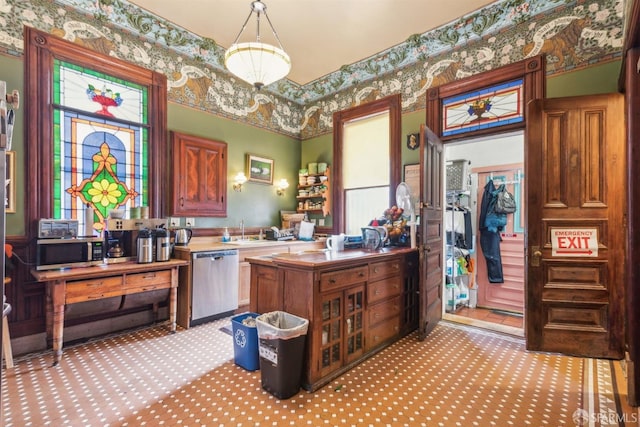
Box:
[53,60,148,232]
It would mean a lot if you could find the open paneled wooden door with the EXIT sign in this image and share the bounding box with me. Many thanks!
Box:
[525,94,627,358]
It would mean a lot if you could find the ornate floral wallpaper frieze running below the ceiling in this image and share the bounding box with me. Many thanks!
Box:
[0,0,624,140]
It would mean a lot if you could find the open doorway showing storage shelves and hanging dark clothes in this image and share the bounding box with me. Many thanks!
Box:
[442,131,526,336]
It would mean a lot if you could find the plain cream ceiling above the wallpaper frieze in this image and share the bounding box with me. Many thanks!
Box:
[129,0,494,85]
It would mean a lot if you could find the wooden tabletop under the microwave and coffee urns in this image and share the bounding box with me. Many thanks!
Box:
[31,258,189,282]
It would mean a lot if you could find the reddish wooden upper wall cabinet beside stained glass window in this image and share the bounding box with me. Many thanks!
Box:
[168,131,227,217]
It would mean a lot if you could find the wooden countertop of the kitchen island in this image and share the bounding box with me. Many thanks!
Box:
[245,246,417,268]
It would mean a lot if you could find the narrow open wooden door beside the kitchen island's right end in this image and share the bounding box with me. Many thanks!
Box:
[418,125,444,339]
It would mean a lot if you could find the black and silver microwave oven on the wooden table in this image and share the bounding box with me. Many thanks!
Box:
[36,237,105,270]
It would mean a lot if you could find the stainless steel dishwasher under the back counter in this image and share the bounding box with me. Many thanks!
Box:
[190,249,239,326]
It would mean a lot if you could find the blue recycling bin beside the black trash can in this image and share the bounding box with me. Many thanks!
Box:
[231,313,260,371]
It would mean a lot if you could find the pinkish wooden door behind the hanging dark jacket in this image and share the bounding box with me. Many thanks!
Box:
[472,163,526,313]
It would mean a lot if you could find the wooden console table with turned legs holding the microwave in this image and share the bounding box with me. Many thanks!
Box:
[31,259,189,366]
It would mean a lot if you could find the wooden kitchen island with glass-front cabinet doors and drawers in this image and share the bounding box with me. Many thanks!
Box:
[246,248,418,391]
